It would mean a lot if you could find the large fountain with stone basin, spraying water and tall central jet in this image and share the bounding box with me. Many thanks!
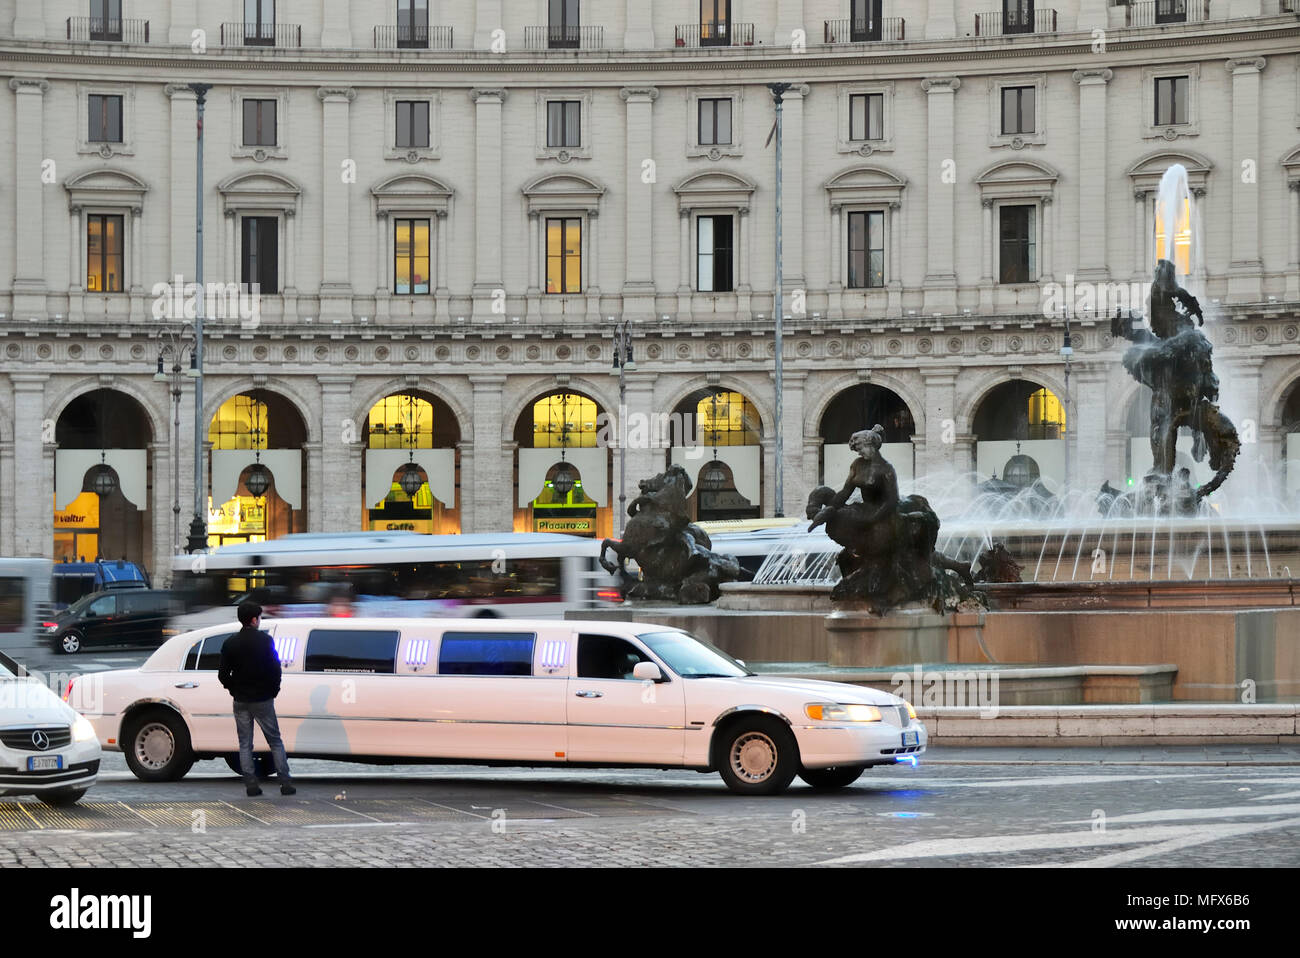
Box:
[590,165,1300,705]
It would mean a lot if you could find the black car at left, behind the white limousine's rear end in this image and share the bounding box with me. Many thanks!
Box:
[42,589,177,654]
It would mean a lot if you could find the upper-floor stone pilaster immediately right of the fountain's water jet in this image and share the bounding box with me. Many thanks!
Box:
[1226,56,1266,303]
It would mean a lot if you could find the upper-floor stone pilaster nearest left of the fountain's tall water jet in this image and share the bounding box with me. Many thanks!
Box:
[1074,69,1114,282]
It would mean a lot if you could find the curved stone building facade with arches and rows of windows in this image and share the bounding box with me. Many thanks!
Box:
[0,0,1300,579]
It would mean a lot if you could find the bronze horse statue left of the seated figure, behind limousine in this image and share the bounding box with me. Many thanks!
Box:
[601,465,753,606]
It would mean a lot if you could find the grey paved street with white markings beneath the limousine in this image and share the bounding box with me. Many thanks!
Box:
[0,749,1300,867]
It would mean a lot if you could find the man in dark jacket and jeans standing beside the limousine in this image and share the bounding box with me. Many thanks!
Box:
[217,602,298,796]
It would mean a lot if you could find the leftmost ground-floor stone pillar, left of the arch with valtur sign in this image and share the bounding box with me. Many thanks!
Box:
[9,374,55,556]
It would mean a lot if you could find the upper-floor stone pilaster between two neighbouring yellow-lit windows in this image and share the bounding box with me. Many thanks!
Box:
[469,87,506,322]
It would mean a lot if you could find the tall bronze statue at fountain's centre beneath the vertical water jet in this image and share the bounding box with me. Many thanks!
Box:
[1112,260,1242,515]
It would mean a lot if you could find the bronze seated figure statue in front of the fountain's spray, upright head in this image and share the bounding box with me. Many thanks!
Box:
[807,425,982,615]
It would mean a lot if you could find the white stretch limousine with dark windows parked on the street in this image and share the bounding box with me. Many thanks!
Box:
[70,619,927,794]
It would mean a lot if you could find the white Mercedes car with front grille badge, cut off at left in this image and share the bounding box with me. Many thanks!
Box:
[0,655,101,805]
